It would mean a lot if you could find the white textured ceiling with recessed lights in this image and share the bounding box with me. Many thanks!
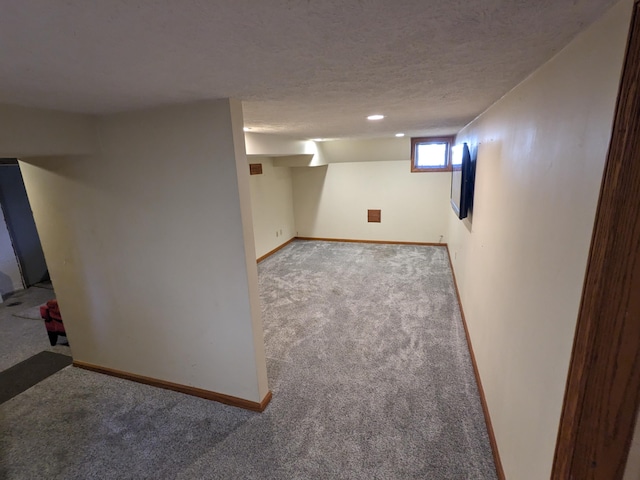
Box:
[0,0,615,138]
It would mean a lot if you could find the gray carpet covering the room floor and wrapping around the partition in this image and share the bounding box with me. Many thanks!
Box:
[0,241,495,480]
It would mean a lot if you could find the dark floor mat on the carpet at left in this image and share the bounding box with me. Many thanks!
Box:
[0,352,73,403]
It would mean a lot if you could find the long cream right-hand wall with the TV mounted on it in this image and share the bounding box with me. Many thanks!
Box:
[448,0,632,480]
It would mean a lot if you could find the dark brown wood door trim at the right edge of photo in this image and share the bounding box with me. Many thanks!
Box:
[551,3,640,480]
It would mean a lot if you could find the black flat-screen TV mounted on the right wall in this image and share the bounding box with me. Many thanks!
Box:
[451,143,476,220]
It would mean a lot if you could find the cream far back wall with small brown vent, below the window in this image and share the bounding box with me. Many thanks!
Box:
[293,161,451,242]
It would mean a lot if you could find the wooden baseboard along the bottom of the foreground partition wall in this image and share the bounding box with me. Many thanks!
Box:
[73,360,271,412]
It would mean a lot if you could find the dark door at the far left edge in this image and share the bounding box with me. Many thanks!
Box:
[0,164,49,287]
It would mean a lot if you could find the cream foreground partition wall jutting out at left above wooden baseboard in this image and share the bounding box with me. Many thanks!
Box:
[21,100,267,401]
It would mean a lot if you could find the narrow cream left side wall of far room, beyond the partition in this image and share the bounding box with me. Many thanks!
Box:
[249,157,296,258]
